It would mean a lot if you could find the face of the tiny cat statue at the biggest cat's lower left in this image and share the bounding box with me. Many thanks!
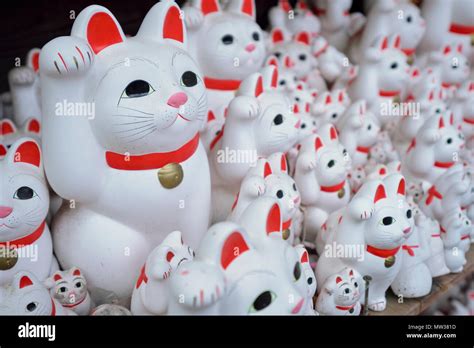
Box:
[45,267,87,306]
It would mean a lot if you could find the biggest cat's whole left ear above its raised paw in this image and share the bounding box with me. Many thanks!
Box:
[71,5,125,54]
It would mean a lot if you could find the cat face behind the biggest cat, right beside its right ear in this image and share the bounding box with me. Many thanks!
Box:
[190,0,265,80]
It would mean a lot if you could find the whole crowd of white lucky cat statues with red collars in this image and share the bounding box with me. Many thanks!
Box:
[0,0,474,315]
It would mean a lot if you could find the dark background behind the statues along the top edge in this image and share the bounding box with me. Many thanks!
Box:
[0,0,362,92]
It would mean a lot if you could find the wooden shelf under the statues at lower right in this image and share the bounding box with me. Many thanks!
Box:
[369,247,474,316]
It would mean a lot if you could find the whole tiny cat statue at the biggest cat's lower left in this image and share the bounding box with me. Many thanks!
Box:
[44,267,94,315]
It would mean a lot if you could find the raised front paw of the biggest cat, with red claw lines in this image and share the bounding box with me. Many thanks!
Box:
[40,36,94,77]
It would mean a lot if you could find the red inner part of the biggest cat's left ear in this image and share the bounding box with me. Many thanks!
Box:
[87,12,123,54]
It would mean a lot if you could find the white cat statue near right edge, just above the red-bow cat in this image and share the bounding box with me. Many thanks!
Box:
[402,115,464,187]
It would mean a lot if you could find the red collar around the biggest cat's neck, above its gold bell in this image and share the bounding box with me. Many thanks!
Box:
[105,133,199,170]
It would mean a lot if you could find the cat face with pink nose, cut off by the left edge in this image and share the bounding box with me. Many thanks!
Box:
[0,138,49,241]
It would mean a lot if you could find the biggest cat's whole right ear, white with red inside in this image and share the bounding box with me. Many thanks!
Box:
[137,1,186,47]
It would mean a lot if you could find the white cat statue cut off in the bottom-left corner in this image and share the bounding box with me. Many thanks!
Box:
[0,271,76,316]
